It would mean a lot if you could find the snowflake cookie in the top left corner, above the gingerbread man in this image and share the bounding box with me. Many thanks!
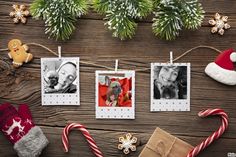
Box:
[9,4,30,23]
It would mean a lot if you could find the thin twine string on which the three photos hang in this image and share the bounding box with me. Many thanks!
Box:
[0,43,221,71]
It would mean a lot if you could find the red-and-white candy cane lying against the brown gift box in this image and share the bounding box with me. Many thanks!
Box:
[187,109,228,157]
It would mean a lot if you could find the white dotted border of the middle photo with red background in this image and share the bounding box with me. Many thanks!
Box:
[95,70,135,119]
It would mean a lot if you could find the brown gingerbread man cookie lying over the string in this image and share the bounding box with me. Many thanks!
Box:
[8,39,33,67]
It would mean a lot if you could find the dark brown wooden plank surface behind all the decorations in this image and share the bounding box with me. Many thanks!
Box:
[0,0,236,157]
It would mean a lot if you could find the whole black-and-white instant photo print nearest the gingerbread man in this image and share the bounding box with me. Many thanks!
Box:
[41,57,80,105]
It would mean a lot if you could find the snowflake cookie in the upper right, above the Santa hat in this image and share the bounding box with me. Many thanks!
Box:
[209,13,230,35]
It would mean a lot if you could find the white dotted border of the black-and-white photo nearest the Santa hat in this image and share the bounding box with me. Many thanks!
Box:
[150,63,191,112]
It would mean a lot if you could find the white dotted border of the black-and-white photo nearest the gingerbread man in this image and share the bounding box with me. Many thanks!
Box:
[41,57,80,105]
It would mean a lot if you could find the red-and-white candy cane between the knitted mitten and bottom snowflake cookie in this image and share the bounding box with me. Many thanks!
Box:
[62,123,103,157]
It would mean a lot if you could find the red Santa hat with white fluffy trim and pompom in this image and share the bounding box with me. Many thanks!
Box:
[205,49,236,85]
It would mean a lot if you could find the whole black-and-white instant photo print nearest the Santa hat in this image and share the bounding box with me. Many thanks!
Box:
[150,63,190,112]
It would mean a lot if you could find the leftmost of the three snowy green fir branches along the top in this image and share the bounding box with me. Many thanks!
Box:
[30,0,88,40]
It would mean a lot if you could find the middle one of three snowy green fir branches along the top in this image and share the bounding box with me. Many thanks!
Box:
[93,0,152,40]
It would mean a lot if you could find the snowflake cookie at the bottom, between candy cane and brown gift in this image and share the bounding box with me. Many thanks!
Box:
[118,133,137,154]
